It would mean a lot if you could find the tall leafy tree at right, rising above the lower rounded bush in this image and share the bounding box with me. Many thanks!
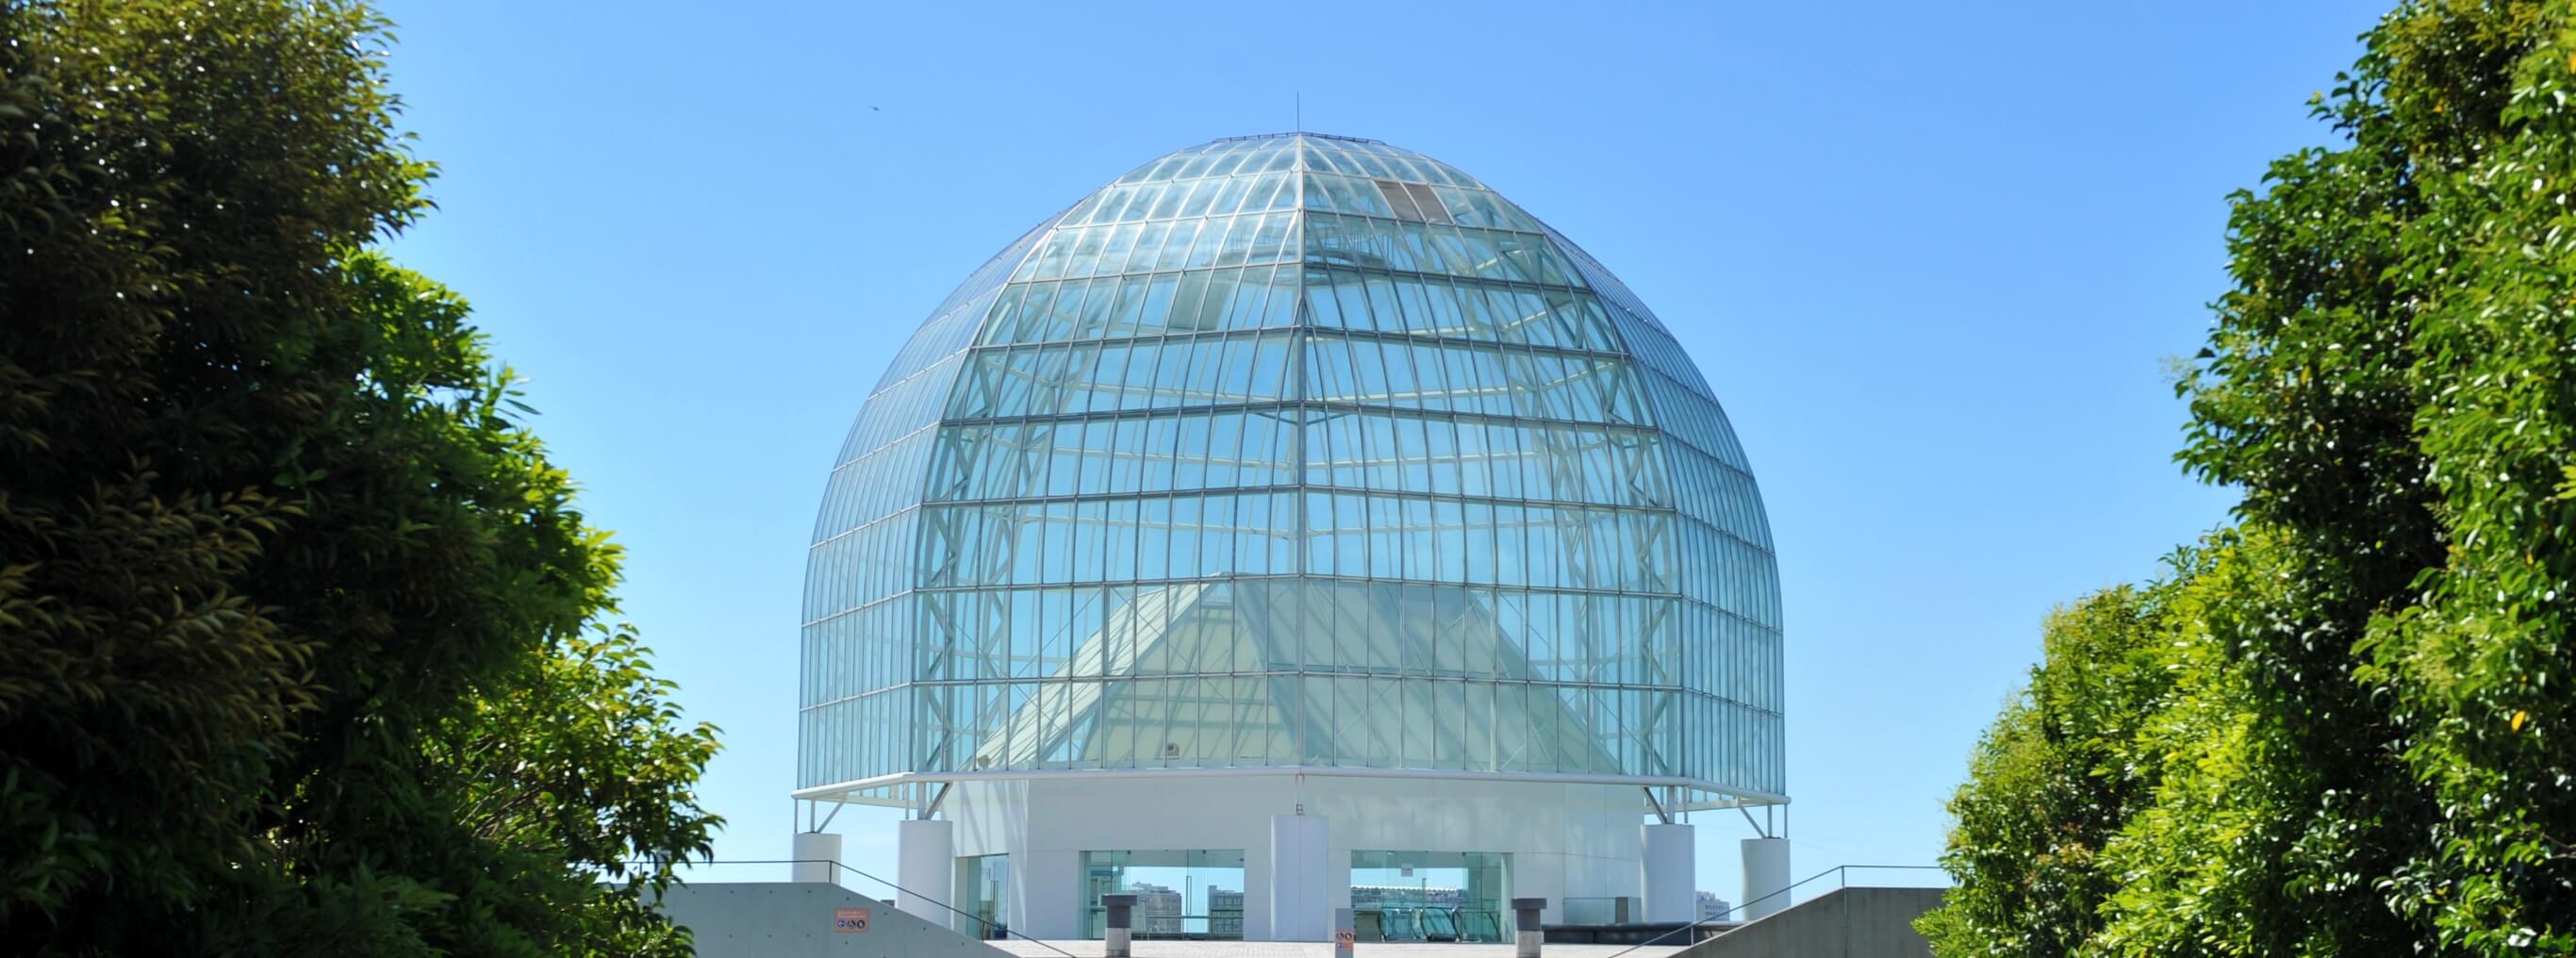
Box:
[2185,3,2576,953]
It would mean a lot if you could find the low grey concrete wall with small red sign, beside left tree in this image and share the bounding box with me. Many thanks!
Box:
[662,881,1007,958]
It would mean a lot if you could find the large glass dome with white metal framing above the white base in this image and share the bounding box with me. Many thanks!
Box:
[799,134,1785,806]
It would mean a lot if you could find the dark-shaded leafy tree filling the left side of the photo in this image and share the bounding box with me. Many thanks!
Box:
[0,0,716,955]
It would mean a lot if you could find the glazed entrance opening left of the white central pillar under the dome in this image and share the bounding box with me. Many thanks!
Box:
[1082,848,1245,940]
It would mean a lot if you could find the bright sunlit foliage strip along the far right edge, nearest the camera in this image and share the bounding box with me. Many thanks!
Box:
[2362,3,2576,955]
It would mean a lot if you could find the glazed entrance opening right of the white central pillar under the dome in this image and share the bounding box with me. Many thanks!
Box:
[1350,852,1507,943]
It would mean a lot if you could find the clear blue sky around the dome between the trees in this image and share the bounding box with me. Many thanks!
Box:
[389,0,2386,899]
